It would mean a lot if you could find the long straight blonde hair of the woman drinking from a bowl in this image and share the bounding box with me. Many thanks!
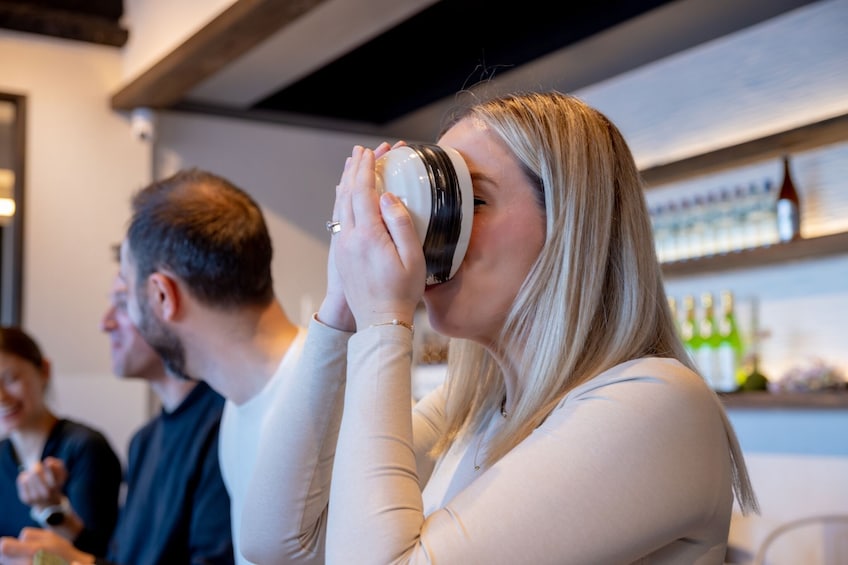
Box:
[435,92,757,513]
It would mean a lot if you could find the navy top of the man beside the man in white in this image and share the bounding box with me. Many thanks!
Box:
[109,382,234,565]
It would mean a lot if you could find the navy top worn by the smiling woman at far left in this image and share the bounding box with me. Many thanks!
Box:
[0,419,121,555]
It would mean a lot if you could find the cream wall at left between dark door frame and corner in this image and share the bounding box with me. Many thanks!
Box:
[0,30,151,457]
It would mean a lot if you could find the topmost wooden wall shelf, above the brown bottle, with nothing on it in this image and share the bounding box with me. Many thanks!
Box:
[641,114,848,190]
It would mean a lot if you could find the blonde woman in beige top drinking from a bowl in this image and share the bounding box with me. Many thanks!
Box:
[242,92,757,564]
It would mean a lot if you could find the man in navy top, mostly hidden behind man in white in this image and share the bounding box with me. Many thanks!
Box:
[0,277,234,565]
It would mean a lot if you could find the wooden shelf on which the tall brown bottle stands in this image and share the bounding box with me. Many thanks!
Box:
[662,232,848,277]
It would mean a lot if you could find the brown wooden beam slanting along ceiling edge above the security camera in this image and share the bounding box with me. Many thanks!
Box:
[111,0,326,110]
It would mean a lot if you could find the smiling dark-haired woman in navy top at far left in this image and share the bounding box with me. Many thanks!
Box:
[0,326,122,553]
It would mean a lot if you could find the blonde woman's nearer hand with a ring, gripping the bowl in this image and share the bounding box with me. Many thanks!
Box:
[330,144,426,329]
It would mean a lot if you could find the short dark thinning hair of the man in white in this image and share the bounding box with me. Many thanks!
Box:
[127,169,274,308]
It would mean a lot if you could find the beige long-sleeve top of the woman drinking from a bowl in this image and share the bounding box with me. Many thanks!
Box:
[242,321,733,565]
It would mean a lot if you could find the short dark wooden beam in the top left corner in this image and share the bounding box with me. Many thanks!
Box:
[0,0,129,47]
